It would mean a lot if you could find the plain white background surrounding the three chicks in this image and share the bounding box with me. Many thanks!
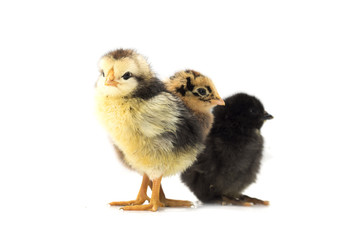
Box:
[0,0,361,239]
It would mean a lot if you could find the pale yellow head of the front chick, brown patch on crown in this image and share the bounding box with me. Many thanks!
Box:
[97,49,154,97]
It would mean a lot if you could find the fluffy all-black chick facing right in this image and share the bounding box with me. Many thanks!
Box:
[181,93,273,206]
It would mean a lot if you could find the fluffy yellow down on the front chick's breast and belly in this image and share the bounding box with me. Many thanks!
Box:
[96,91,203,179]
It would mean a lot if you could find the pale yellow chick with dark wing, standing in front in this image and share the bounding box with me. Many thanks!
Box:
[95,49,204,211]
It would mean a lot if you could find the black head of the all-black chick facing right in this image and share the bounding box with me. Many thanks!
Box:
[214,93,273,129]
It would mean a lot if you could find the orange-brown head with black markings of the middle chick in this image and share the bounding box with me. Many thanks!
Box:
[166,70,224,112]
